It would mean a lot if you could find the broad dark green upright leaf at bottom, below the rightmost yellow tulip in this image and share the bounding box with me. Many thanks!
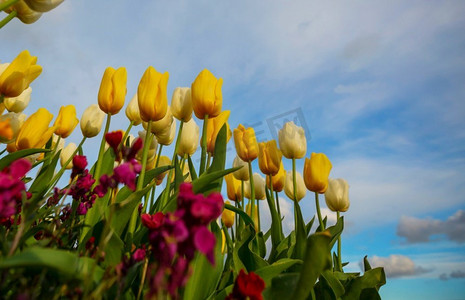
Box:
[292,231,331,300]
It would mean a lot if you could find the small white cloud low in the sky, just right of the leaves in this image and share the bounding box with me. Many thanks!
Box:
[360,254,431,278]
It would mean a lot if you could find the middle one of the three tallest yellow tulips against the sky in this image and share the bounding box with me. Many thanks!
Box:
[137,66,169,122]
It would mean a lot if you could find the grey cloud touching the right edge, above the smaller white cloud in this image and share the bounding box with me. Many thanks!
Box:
[397,210,465,243]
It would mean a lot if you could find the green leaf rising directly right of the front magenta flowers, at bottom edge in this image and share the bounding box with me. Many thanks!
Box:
[183,222,223,300]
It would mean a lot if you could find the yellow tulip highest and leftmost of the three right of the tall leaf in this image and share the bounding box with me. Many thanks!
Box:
[234,124,258,162]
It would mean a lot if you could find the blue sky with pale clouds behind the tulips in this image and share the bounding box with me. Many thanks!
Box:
[0,0,465,299]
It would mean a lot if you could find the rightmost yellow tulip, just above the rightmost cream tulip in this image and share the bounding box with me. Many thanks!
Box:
[304,152,332,194]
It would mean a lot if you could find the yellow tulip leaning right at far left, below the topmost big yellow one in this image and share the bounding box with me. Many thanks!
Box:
[16,108,56,150]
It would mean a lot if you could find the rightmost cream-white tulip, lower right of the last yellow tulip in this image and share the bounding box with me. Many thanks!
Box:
[325,178,350,212]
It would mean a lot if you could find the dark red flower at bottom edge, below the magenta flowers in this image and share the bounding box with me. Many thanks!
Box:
[226,269,265,300]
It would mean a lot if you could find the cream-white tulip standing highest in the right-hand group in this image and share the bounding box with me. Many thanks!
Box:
[278,122,307,159]
